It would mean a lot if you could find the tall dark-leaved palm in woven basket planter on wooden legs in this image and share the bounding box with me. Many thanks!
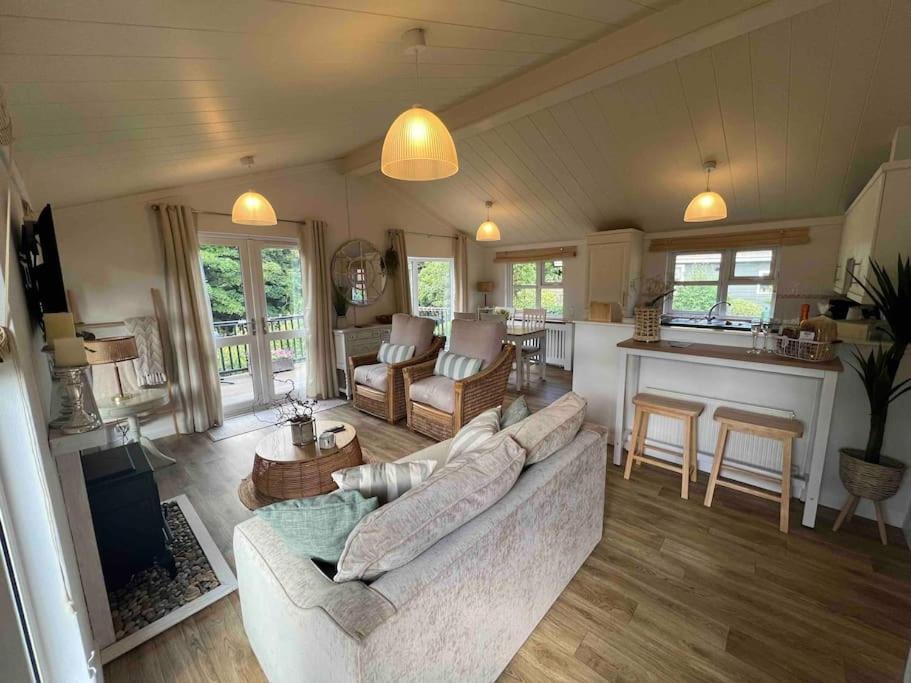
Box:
[838,255,911,543]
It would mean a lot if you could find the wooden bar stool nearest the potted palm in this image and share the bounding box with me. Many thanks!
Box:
[705,408,803,533]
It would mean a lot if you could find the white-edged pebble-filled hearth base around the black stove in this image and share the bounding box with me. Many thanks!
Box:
[101,495,237,662]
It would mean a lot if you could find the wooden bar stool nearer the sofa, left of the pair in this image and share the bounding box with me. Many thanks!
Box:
[623,394,705,500]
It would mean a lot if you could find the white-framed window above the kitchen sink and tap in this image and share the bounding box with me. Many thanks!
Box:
[664,249,778,318]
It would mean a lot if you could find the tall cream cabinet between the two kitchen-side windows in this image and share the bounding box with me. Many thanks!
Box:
[586,228,642,315]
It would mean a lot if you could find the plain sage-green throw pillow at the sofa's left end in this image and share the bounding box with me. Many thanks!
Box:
[256,491,378,564]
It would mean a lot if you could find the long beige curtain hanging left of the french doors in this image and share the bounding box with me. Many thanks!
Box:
[152,204,224,434]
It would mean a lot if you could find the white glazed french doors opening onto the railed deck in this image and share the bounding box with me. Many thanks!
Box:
[199,235,307,415]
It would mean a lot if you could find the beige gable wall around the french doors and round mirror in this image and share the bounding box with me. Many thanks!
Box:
[54,164,460,324]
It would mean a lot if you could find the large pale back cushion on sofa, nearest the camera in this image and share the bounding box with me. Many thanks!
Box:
[334,438,525,583]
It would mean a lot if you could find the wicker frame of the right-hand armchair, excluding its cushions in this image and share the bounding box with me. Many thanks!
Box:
[403,344,515,441]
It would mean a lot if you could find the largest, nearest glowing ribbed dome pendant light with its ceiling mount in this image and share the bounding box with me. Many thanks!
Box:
[380,28,459,181]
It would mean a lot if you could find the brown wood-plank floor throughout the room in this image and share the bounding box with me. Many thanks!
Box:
[104,370,911,683]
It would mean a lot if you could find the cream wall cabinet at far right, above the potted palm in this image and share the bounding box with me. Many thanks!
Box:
[835,160,911,303]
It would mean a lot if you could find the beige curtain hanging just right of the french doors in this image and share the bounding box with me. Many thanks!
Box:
[298,221,338,399]
